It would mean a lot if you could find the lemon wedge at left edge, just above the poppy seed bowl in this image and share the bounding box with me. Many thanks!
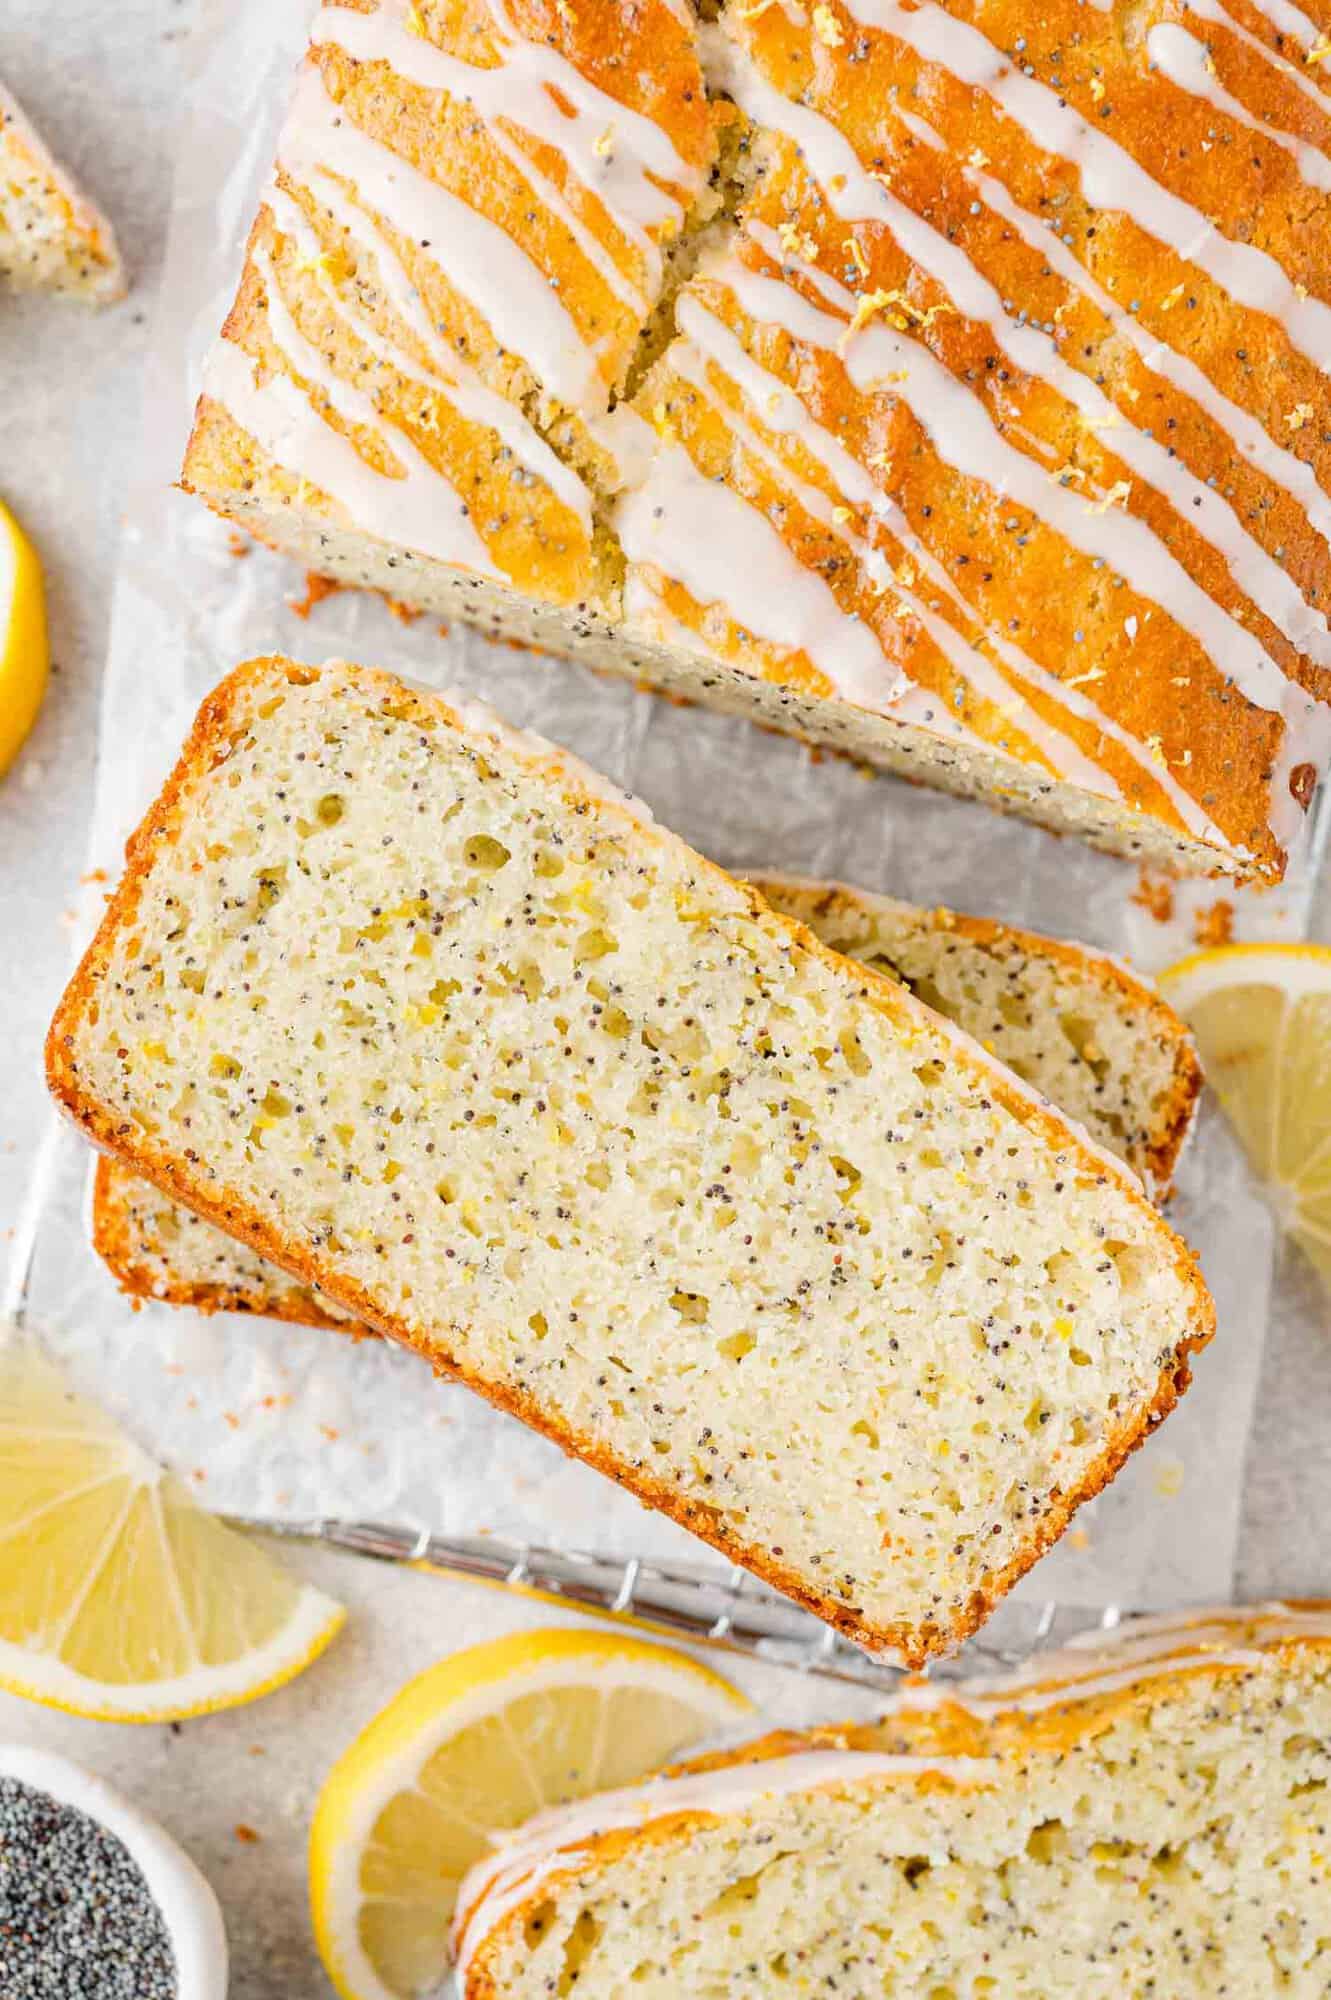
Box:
[0,1334,344,1722]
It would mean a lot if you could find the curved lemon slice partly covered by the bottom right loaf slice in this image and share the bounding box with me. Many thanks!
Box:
[310,1630,751,2000]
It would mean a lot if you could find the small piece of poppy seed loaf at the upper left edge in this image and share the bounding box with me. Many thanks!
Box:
[0,84,126,306]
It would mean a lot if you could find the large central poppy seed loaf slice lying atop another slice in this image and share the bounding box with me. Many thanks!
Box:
[48,660,1213,1660]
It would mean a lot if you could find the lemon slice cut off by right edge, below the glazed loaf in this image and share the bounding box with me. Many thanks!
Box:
[1159,944,1331,1288]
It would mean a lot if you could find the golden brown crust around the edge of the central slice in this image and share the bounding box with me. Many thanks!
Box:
[46,654,1215,1666]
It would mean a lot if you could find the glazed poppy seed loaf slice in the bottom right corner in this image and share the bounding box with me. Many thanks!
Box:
[454,1604,1331,2000]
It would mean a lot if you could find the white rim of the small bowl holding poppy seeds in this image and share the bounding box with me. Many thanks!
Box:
[0,1742,226,2000]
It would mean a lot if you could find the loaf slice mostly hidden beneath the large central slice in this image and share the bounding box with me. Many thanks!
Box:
[92,874,1201,1328]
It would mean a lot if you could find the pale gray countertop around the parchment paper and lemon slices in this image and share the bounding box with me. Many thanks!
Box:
[0,0,1331,2000]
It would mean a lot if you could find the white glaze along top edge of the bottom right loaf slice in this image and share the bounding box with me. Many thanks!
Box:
[454,1604,1331,1986]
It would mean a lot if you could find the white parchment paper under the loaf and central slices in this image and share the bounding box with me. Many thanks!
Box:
[30,0,1309,1608]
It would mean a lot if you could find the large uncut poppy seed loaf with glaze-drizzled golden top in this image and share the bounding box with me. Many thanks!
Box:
[184,0,1331,878]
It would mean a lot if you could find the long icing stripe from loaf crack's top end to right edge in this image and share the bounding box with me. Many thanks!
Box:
[707,36,1331,680]
